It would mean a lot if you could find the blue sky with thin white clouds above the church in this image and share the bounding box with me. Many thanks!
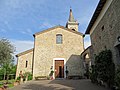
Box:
[0,0,99,60]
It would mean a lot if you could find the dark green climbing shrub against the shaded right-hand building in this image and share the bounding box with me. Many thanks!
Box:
[93,50,115,86]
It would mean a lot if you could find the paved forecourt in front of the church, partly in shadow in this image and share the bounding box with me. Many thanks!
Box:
[9,80,109,90]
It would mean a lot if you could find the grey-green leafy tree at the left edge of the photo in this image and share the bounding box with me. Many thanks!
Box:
[0,39,15,79]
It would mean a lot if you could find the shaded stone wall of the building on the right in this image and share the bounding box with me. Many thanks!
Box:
[90,0,120,63]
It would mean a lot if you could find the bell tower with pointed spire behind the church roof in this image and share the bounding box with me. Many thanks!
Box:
[66,9,79,31]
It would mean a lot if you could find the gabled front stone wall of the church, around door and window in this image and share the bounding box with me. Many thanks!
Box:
[33,27,83,77]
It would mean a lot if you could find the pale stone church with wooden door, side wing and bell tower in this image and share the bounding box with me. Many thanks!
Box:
[16,9,84,78]
